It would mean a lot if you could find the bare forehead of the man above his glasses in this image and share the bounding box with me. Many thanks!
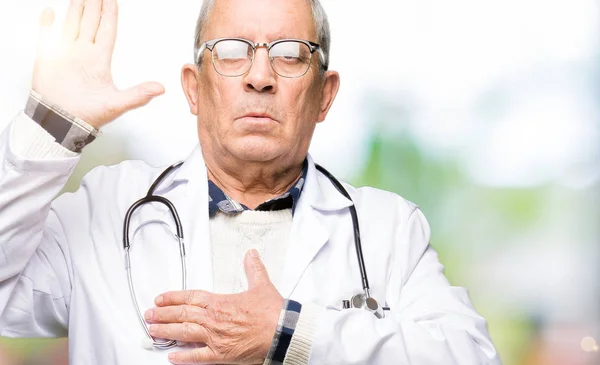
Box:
[204,0,317,42]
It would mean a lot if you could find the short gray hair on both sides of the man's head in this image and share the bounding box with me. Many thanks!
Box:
[194,0,331,71]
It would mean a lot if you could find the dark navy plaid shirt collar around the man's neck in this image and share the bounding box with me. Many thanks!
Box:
[208,160,308,217]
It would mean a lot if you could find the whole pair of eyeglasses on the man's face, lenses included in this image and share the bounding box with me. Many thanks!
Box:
[196,38,327,78]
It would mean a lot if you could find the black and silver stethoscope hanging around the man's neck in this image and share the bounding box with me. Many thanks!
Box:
[123,161,390,350]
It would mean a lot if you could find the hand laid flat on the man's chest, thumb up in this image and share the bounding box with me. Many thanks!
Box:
[146,250,284,364]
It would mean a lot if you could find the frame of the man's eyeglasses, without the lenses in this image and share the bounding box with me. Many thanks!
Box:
[195,37,327,79]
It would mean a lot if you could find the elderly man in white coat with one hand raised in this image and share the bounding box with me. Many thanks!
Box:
[0,0,499,365]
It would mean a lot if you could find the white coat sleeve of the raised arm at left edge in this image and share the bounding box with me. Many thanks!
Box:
[0,113,79,337]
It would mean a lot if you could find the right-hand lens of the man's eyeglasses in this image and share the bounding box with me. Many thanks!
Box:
[269,41,312,77]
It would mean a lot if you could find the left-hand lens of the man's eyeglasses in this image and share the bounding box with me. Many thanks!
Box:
[212,39,253,76]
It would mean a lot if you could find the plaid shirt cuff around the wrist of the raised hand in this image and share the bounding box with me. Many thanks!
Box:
[24,90,100,153]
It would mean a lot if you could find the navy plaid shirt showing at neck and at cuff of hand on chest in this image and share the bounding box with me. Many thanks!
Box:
[208,160,308,365]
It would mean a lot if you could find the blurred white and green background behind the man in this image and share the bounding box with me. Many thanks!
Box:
[0,0,600,365]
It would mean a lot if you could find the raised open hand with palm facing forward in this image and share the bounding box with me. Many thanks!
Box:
[32,0,164,128]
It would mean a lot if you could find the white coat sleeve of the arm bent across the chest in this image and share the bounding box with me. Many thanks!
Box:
[309,209,500,365]
